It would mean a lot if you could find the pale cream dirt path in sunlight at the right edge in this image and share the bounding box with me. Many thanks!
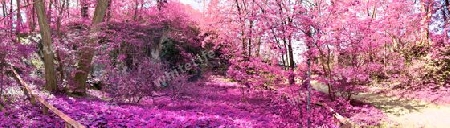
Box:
[312,82,450,128]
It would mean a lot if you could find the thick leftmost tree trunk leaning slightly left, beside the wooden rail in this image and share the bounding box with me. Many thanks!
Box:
[34,0,57,91]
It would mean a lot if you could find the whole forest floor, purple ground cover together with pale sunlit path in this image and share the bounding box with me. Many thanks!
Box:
[0,75,450,128]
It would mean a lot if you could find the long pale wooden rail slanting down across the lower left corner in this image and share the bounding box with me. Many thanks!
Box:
[10,65,86,128]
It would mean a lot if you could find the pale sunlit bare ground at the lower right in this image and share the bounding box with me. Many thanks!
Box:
[312,82,450,128]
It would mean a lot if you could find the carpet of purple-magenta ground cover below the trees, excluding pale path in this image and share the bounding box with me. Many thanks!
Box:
[0,74,298,128]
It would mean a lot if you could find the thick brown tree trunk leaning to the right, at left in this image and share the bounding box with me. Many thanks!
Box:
[75,0,109,95]
